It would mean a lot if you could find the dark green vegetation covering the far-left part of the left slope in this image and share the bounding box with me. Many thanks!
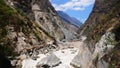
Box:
[0,0,25,56]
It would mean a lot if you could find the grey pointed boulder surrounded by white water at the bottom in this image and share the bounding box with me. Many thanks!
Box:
[37,54,61,68]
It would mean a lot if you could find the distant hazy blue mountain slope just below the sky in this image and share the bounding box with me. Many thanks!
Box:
[57,11,82,27]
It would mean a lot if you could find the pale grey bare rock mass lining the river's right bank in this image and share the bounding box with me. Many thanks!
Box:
[71,32,116,68]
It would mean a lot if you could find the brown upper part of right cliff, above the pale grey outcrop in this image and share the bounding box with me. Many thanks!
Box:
[78,0,120,42]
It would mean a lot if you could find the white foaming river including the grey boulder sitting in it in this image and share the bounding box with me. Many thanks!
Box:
[22,47,79,68]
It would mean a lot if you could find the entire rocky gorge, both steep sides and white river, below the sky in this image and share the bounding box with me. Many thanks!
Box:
[0,0,120,68]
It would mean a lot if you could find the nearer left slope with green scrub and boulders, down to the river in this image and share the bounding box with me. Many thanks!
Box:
[0,0,56,68]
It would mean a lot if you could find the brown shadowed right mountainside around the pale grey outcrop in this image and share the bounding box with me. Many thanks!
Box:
[78,0,120,68]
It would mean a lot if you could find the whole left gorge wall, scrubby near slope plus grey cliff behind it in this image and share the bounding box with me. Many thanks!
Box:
[0,0,76,68]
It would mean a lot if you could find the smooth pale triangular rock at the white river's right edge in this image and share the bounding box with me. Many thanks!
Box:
[70,45,91,68]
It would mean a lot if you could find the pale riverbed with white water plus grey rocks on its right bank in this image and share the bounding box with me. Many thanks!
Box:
[22,33,114,68]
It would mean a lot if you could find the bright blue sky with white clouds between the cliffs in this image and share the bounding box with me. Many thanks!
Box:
[50,0,95,23]
